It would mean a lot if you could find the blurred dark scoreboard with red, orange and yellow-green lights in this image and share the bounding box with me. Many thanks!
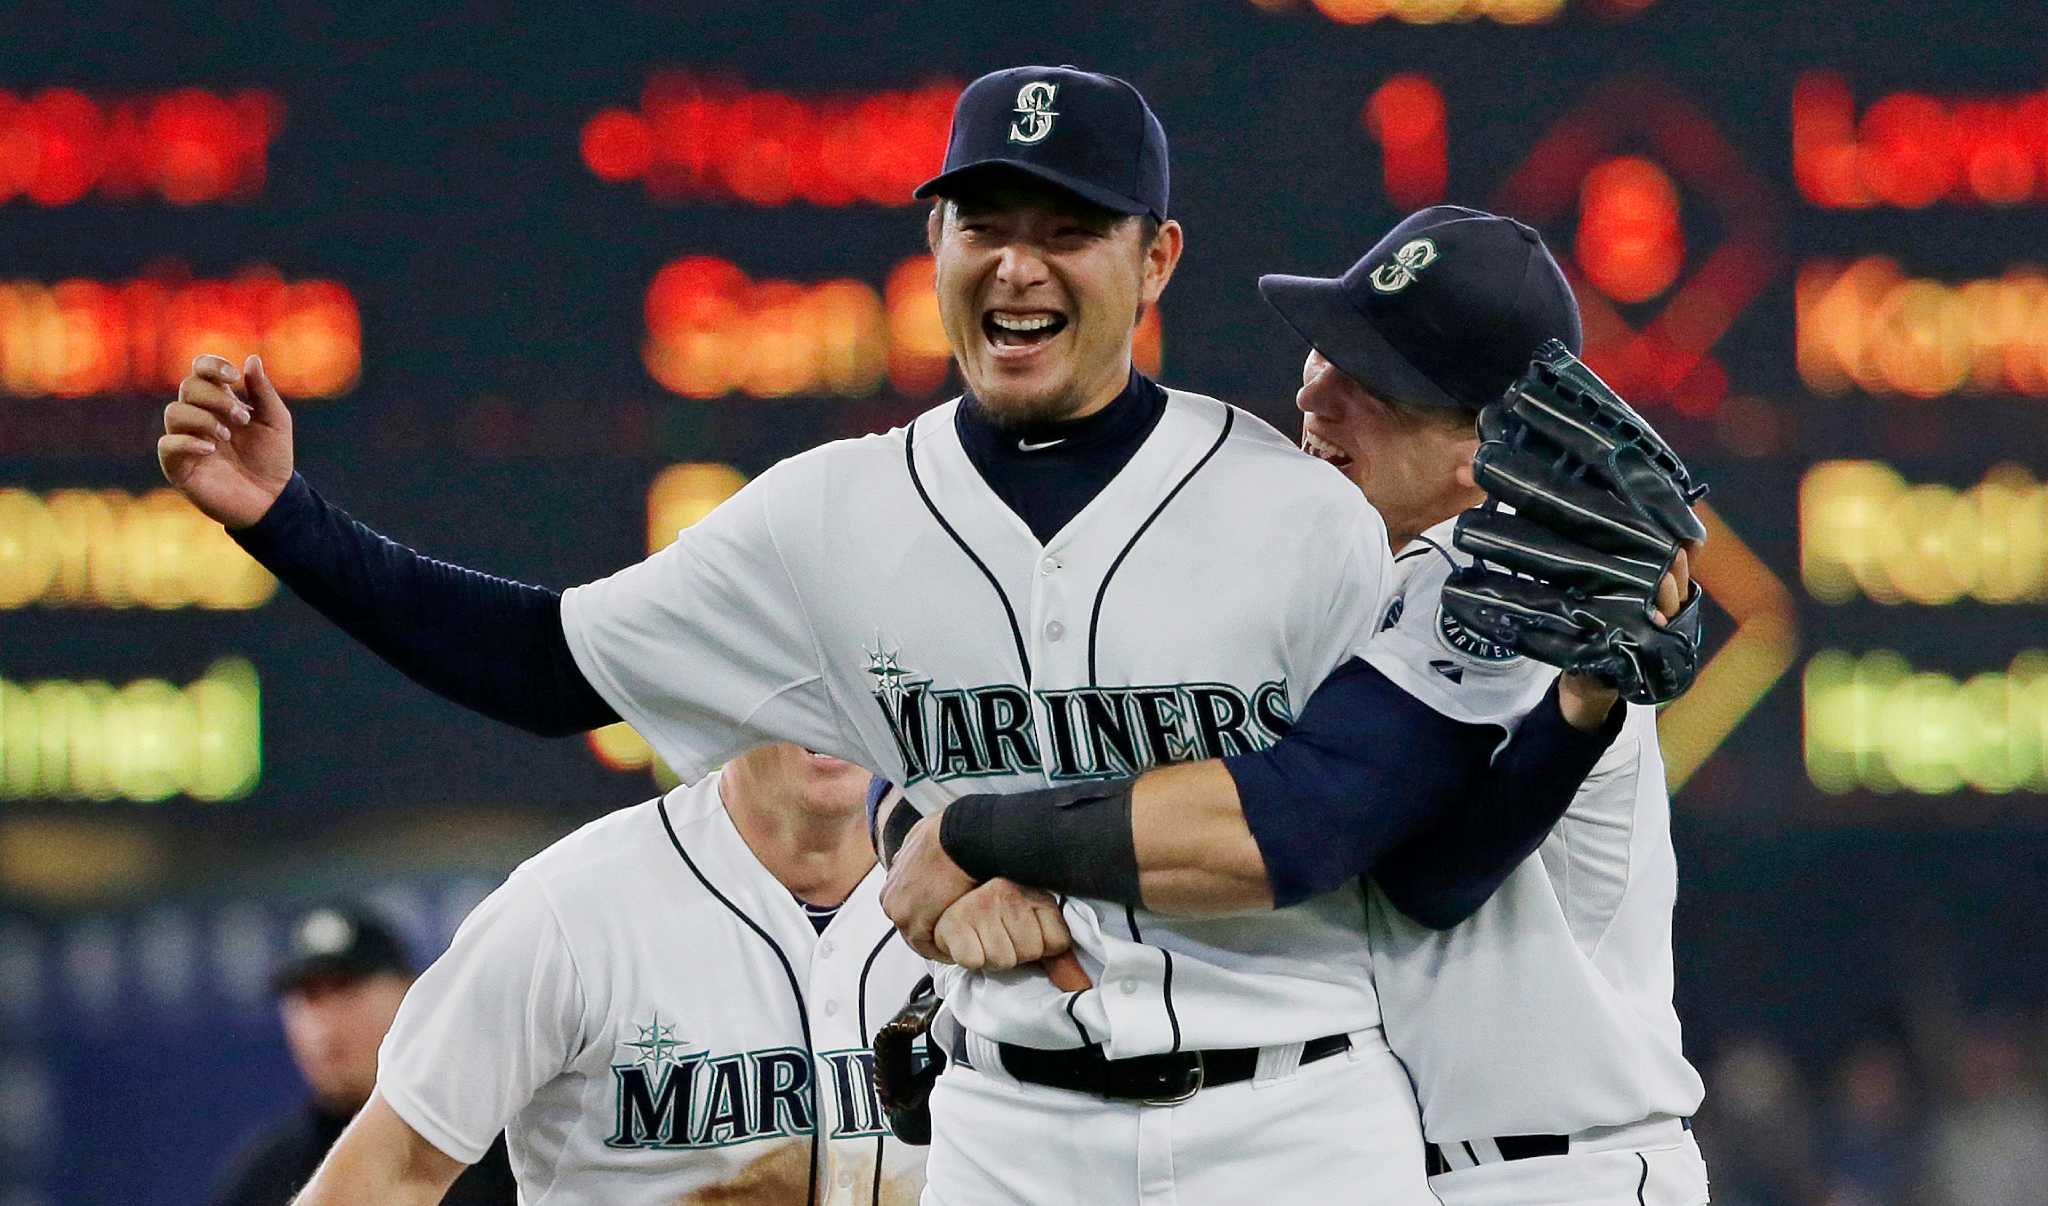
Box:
[0,0,2048,823]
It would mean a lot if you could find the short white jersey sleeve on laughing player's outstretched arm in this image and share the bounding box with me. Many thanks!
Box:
[561,463,843,782]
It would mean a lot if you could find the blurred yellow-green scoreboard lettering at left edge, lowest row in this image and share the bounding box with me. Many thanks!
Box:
[0,657,262,803]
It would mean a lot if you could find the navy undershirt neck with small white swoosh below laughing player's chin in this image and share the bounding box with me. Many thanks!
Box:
[952,369,1165,545]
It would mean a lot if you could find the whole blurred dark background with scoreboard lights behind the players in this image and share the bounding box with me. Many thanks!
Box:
[0,0,2048,1206]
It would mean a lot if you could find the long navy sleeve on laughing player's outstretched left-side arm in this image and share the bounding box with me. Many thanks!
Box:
[229,473,618,737]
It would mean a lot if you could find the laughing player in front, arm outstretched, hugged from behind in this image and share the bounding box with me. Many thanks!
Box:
[158,68,1687,1206]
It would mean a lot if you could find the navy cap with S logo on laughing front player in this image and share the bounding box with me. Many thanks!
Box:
[913,68,1167,221]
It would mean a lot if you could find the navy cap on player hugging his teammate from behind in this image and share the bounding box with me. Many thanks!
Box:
[1260,205,1581,412]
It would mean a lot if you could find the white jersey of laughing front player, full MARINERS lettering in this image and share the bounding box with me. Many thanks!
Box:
[561,391,1391,1059]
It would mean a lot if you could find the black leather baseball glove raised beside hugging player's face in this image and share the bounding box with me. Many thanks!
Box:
[1444,340,1706,704]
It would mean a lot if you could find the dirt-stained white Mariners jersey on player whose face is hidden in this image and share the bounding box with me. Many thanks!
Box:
[377,776,924,1206]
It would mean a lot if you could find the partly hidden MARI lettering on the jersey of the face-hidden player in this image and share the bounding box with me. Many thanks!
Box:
[604,1014,889,1149]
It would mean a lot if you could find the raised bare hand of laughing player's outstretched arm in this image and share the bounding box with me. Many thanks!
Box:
[156,356,293,528]
